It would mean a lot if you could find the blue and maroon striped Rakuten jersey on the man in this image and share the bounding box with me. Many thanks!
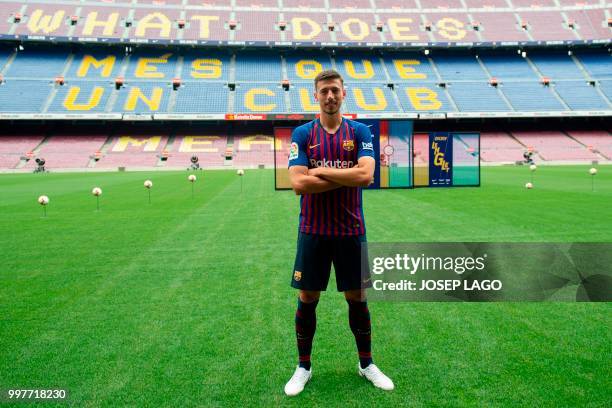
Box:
[289,118,374,236]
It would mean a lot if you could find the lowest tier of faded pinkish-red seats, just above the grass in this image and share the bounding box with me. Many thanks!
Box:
[0,127,612,171]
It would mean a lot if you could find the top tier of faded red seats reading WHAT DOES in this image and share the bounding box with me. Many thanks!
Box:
[0,0,611,46]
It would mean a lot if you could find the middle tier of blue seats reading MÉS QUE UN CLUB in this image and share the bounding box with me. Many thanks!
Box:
[0,45,612,118]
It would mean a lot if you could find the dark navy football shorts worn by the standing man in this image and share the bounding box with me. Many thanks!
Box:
[291,232,372,292]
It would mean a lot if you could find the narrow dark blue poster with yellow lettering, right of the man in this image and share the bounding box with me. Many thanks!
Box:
[429,132,453,187]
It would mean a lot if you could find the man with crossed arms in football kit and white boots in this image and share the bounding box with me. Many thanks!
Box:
[285,70,393,396]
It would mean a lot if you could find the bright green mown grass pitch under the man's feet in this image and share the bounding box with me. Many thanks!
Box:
[0,166,612,407]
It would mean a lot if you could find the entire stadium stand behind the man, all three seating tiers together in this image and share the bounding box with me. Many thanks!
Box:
[0,0,612,171]
